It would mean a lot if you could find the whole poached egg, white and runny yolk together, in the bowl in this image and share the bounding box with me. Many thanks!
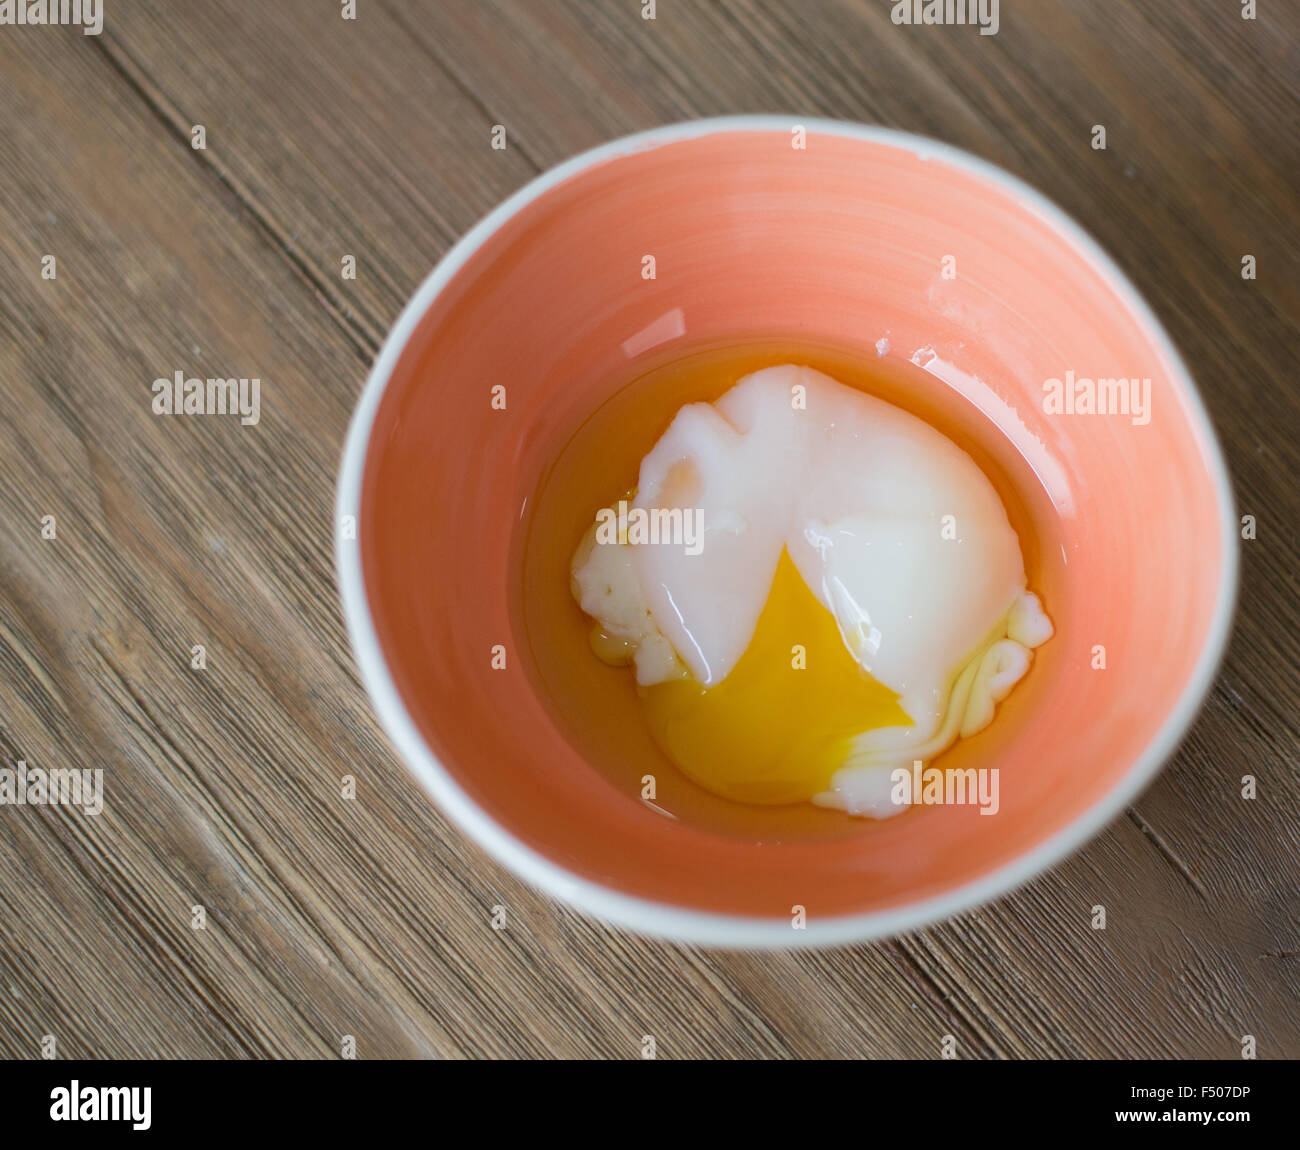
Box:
[572,365,1052,817]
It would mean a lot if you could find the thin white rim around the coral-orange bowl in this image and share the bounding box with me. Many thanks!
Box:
[334,114,1238,950]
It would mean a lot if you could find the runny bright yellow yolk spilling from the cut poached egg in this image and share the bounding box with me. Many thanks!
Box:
[641,550,913,804]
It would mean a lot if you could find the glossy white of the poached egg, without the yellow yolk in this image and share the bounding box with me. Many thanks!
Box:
[573,365,1052,817]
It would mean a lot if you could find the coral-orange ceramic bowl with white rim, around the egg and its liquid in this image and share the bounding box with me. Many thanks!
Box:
[337,117,1236,946]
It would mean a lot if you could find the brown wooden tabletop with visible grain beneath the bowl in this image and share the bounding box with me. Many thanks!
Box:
[0,0,1300,1058]
